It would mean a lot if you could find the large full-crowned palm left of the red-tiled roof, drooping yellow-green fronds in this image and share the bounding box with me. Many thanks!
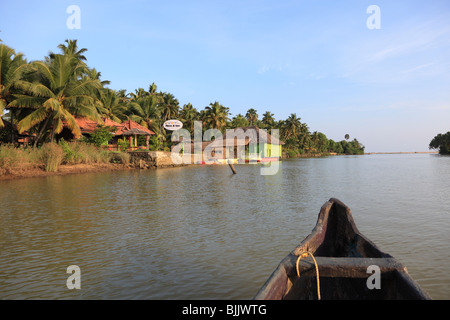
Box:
[9,54,102,144]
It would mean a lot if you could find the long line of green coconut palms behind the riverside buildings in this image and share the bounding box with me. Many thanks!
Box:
[0,40,364,156]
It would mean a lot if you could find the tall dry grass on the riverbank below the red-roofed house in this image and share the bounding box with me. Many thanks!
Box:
[0,140,130,175]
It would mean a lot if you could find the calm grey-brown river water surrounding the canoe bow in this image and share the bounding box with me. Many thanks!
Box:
[0,154,450,300]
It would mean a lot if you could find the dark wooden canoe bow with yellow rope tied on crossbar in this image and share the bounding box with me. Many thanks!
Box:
[254,198,431,300]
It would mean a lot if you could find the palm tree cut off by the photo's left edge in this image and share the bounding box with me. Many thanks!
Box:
[0,44,29,128]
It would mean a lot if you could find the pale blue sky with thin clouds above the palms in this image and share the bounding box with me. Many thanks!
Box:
[0,0,450,152]
